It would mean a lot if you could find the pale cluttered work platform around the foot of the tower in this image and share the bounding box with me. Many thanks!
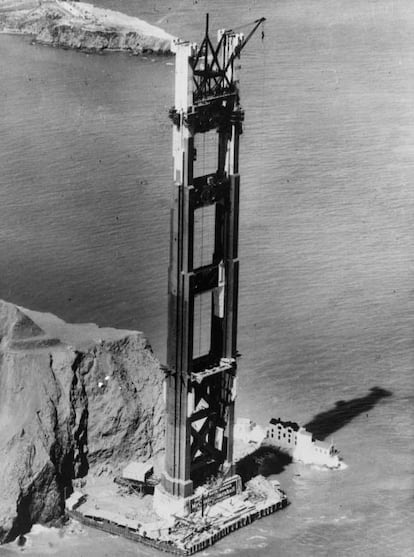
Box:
[67,472,288,555]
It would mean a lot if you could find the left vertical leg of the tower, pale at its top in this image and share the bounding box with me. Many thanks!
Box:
[162,43,194,497]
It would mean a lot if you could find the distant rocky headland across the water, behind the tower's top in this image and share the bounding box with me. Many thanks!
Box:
[0,0,175,55]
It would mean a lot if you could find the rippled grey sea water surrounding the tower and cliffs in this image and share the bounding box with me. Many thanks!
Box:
[0,0,414,557]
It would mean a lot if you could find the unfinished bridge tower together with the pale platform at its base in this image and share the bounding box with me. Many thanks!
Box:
[66,14,288,555]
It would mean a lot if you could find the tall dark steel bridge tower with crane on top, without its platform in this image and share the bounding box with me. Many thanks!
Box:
[162,16,263,498]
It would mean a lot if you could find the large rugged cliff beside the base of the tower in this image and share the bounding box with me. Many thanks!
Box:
[0,301,164,543]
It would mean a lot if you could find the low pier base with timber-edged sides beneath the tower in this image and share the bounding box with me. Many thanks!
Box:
[67,476,288,556]
